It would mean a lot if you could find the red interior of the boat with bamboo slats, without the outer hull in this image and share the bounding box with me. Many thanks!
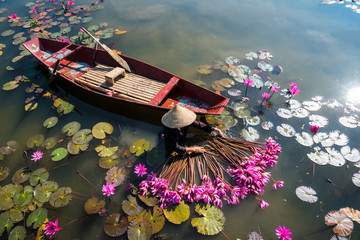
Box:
[24,38,226,114]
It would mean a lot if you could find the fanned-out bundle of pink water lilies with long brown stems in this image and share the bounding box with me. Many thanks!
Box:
[139,137,283,209]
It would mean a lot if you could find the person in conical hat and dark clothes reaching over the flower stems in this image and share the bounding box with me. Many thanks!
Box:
[161,104,224,155]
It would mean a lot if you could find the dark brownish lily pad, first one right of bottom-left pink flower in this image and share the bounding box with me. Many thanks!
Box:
[104,213,128,237]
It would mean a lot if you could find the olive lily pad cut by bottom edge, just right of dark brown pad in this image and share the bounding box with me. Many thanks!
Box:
[128,218,153,240]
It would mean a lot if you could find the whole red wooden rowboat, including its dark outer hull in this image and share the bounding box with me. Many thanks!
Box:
[23,38,229,122]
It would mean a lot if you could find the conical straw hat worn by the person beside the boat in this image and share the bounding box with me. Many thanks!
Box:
[161,104,196,128]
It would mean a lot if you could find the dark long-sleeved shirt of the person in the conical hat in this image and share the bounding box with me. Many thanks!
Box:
[164,121,214,154]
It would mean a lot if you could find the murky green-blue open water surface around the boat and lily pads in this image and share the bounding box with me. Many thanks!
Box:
[0,0,360,239]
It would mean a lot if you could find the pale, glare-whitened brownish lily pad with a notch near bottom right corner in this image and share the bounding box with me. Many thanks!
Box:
[325,211,354,236]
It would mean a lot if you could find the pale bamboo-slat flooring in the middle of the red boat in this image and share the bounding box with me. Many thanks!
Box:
[75,64,165,103]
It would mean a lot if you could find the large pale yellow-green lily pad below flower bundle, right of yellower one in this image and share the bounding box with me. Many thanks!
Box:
[191,204,225,235]
